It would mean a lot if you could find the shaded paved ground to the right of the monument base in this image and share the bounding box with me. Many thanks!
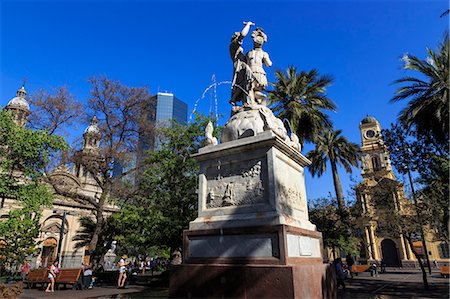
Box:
[338,269,450,299]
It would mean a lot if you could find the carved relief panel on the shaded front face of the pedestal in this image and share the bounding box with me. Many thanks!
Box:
[206,158,267,209]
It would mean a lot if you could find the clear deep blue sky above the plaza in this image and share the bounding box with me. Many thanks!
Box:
[0,0,449,204]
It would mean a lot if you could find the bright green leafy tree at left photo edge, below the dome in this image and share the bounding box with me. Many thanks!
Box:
[0,110,67,267]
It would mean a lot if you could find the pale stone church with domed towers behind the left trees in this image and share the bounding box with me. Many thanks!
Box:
[0,86,118,268]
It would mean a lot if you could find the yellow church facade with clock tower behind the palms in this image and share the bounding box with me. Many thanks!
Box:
[356,116,449,267]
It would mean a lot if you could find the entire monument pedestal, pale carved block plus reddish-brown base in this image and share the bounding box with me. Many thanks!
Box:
[169,130,335,298]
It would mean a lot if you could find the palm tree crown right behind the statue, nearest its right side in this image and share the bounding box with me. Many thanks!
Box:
[269,66,336,146]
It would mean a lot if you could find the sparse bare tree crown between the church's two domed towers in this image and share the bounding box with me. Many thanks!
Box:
[28,87,83,135]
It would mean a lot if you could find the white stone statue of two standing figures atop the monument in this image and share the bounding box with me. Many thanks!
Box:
[230,22,272,107]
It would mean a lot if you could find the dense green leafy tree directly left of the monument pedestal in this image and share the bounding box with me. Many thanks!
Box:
[113,115,219,254]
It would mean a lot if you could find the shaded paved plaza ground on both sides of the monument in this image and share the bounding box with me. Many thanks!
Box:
[20,269,450,299]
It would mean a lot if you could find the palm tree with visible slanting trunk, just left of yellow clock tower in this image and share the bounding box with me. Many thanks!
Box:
[306,129,358,211]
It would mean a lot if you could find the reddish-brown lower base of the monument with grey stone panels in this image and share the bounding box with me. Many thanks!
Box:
[169,225,336,298]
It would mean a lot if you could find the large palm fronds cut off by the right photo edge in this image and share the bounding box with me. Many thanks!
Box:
[391,34,450,149]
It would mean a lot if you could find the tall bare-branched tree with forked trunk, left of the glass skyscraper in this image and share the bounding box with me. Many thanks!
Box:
[51,77,150,264]
